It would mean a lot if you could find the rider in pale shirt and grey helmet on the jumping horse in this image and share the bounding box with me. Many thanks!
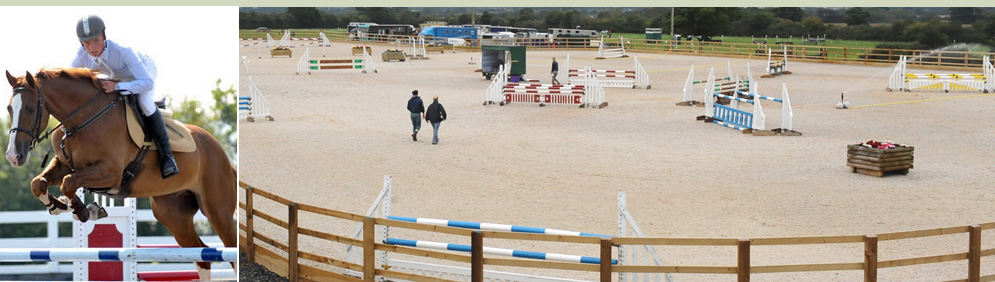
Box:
[72,15,180,178]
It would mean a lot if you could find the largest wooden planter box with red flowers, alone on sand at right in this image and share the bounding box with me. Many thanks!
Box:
[846,144,915,177]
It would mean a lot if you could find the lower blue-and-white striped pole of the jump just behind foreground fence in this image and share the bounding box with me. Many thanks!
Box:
[384,238,618,264]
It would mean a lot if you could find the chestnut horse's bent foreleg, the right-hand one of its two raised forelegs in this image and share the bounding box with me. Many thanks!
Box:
[60,162,121,222]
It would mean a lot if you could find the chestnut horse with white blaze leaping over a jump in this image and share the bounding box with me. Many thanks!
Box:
[7,69,237,279]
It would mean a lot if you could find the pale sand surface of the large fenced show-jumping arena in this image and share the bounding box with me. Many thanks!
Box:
[239,41,995,281]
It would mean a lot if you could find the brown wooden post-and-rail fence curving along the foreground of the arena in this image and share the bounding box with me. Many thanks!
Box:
[239,182,995,281]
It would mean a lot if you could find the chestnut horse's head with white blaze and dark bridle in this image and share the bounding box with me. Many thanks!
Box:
[7,71,49,167]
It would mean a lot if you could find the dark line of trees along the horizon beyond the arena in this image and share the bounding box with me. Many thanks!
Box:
[239,7,995,49]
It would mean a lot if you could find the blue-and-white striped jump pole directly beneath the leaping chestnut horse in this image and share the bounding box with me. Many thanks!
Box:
[0,248,238,262]
